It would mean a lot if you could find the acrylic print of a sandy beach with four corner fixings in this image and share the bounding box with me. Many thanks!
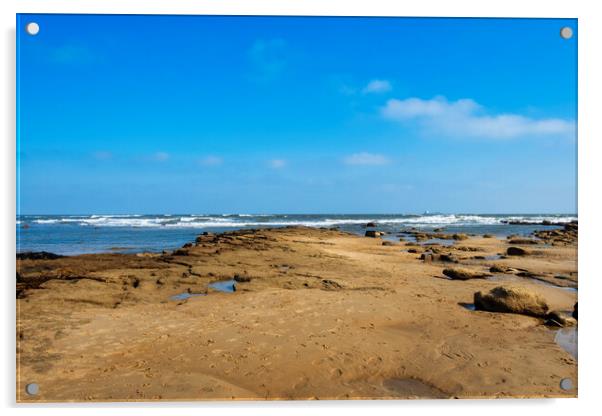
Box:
[16,14,578,402]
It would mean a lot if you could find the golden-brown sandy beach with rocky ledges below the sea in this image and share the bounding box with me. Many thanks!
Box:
[17,228,577,402]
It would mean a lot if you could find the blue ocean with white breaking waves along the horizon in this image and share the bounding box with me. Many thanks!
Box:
[17,214,577,255]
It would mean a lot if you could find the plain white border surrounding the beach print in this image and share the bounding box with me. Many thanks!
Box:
[0,0,602,416]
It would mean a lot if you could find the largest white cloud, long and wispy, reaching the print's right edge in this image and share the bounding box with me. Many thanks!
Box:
[381,96,575,139]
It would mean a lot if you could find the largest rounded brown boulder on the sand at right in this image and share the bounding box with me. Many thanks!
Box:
[474,286,549,317]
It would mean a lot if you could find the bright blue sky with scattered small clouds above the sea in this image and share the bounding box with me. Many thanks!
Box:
[17,14,577,214]
